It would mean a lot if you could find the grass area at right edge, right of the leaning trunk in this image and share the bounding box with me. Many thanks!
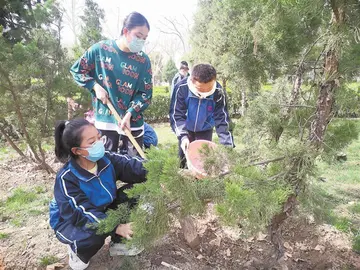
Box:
[312,122,360,252]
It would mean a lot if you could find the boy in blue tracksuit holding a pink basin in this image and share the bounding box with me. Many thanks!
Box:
[169,64,235,168]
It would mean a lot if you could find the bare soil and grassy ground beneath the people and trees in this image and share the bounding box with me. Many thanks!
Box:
[0,123,360,270]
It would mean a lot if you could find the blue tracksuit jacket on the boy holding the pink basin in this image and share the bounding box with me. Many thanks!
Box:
[169,78,235,147]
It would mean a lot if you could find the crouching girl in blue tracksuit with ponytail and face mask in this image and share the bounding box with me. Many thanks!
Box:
[50,119,146,270]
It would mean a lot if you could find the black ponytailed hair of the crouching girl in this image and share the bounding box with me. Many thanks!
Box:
[55,118,91,162]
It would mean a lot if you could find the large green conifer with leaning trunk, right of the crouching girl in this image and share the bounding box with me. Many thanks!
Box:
[97,0,360,257]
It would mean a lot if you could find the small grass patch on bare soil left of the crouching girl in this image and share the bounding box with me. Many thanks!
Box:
[0,186,50,227]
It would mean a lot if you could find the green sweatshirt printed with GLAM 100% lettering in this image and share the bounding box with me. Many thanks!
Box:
[70,40,152,133]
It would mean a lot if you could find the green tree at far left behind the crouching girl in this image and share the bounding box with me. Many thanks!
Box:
[0,1,76,172]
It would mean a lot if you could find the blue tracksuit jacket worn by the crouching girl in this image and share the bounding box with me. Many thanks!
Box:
[50,152,146,244]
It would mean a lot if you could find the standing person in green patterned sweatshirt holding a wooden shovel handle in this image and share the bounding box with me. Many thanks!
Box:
[70,12,152,154]
